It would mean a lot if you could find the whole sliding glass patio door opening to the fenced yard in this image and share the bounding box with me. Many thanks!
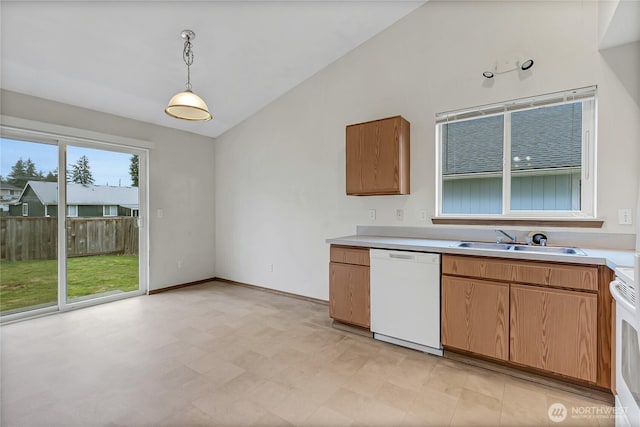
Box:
[0,129,147,320]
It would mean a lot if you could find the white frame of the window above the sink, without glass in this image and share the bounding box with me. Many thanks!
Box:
[435,86,597,220]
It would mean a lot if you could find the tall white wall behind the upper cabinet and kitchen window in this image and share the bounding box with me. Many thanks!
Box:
[215,0,640,299]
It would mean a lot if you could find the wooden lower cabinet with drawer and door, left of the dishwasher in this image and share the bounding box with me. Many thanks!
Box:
[329,246,371,329]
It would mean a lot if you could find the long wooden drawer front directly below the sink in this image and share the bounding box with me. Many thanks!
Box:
[442,255,598,291]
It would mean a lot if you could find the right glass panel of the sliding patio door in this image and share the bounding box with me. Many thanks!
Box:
[65,145,140,303]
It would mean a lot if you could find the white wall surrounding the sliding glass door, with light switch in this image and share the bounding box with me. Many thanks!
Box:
[0,90,215,289]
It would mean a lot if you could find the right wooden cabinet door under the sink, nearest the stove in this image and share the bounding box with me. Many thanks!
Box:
[510,285,598,382]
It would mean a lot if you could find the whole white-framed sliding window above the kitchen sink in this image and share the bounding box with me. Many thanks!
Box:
[436,87,596,218]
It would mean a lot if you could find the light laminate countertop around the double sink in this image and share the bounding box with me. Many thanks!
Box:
[326,235,633,270]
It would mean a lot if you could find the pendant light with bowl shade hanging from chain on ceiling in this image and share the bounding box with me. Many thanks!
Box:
[164,30,212,121]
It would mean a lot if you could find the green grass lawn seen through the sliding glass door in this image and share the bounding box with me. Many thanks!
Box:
[0,255,138,312]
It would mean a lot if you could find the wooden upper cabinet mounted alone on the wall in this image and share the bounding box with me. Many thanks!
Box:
[346,116,410,196]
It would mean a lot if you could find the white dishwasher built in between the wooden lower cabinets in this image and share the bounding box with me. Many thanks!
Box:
[370,249,442,356]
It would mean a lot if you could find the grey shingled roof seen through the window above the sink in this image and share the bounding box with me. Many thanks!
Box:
[442,103,582,175]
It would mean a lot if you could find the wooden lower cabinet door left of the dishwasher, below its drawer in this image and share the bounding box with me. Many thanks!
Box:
[329,262,371,328]
